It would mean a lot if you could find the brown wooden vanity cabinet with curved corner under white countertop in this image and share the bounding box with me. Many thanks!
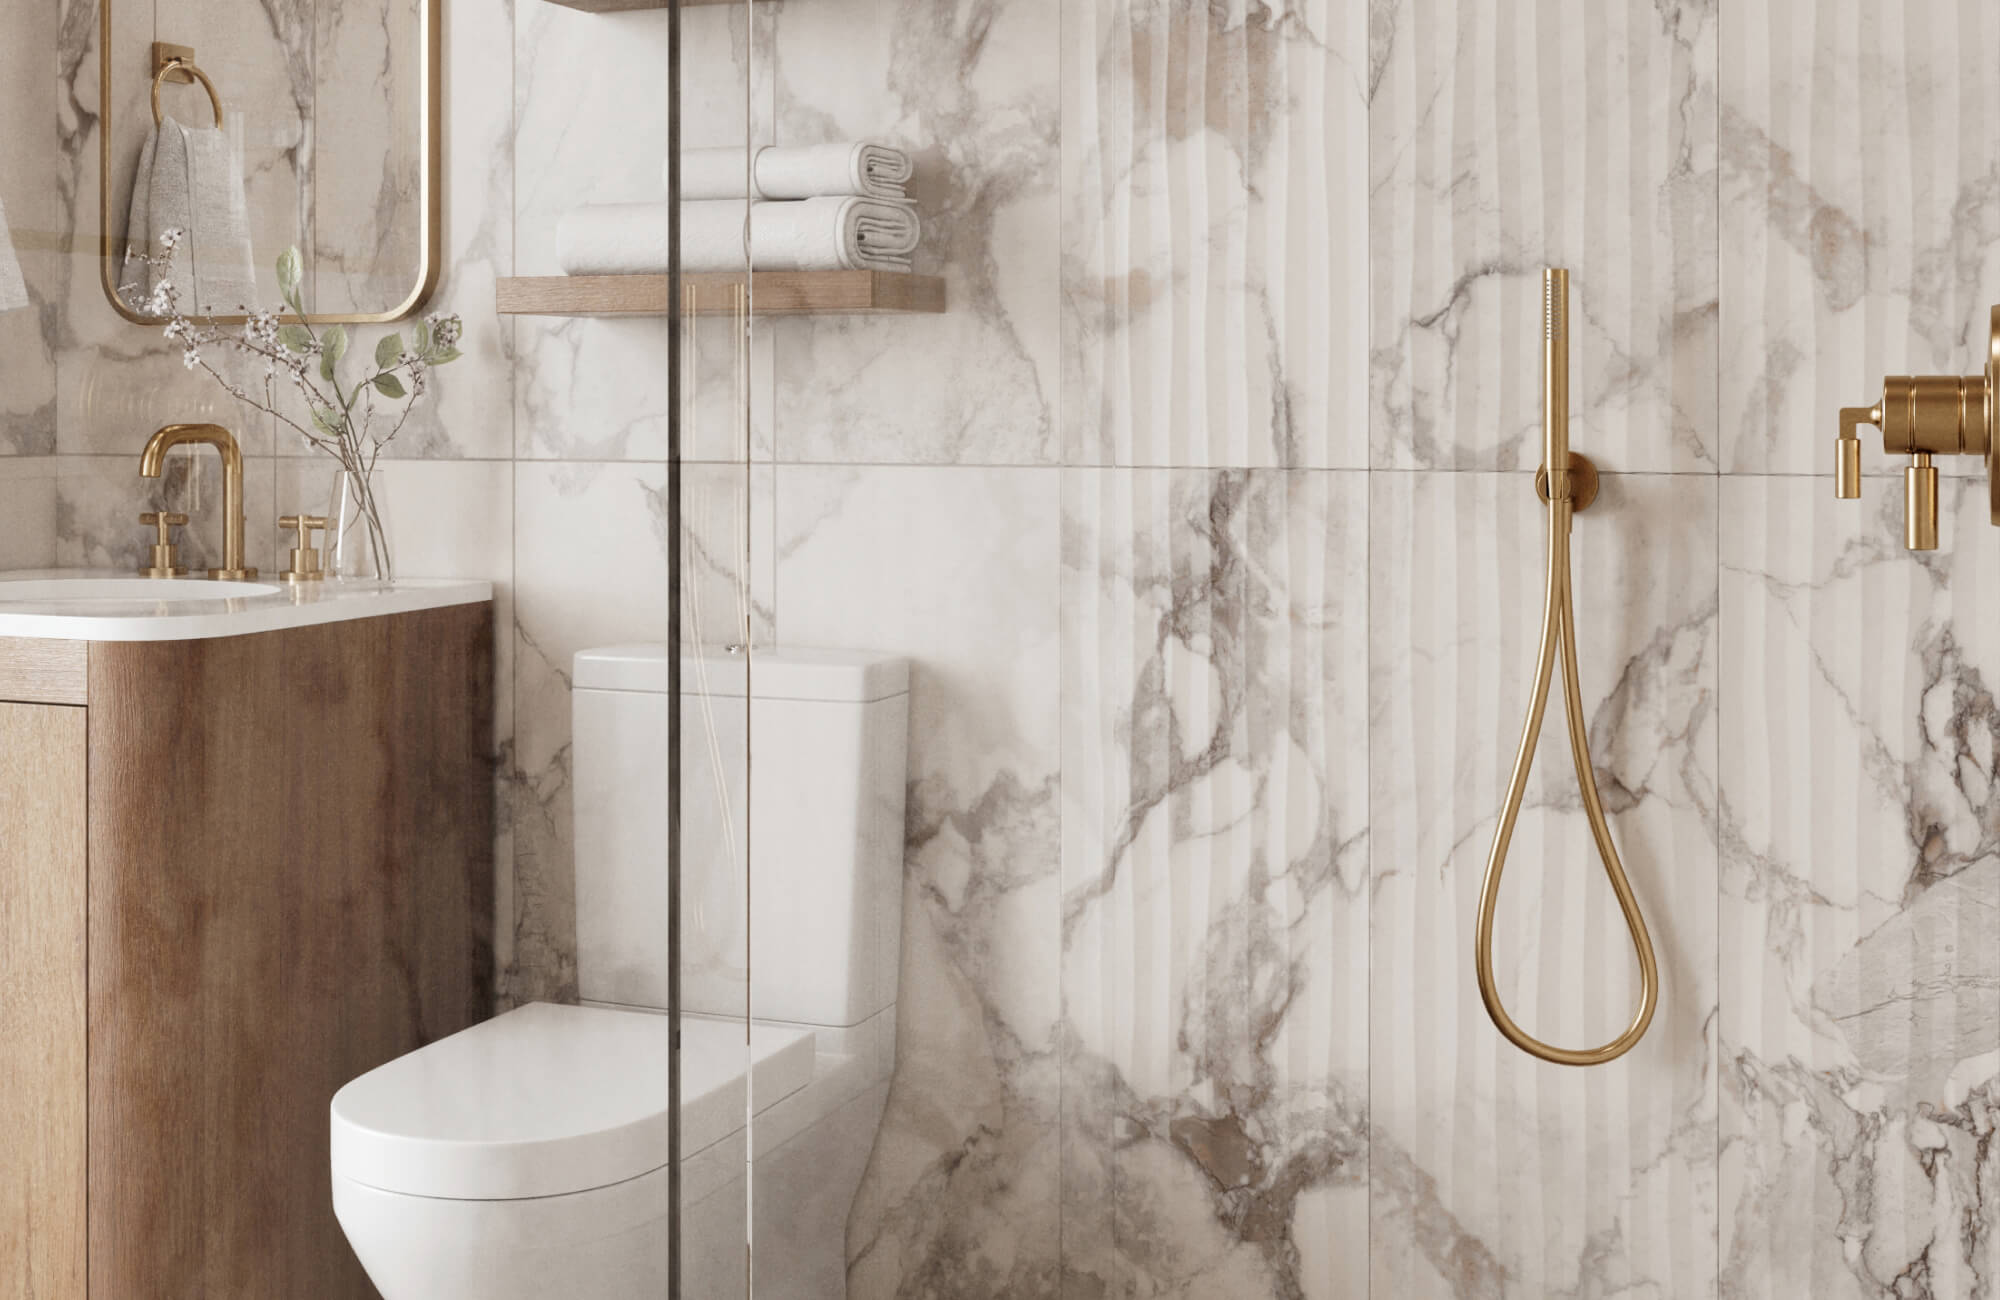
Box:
[0,602,494,1300]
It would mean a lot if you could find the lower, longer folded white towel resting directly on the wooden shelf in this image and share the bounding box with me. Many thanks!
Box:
[556,196,922,276]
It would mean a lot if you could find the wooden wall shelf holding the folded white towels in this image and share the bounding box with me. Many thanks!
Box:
[496,270,944,316]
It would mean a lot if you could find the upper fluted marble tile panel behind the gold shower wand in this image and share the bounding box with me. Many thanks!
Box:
[1368,0,1718,470]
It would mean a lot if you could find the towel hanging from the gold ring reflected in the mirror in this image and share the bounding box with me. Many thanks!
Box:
[118,118,256,316]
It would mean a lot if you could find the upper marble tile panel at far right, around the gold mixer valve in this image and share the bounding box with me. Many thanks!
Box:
[1718,0,2000,474]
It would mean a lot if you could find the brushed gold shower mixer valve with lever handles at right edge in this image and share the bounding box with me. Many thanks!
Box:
[1834,306,2000,550]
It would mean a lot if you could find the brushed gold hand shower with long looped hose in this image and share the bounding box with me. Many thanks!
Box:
[1472,268,1660,1066]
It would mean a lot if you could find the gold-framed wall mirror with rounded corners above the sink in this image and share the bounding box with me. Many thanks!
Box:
[98,0,444,326]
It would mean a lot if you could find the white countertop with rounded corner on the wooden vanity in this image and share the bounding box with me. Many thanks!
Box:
[0,568,494,640]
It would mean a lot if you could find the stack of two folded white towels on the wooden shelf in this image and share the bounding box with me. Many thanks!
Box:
[556,142,922,276]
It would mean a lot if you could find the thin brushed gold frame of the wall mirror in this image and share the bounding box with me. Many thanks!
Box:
[98,0,444,326]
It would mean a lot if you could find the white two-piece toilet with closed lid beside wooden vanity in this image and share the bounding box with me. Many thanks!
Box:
[332,646,908,1300]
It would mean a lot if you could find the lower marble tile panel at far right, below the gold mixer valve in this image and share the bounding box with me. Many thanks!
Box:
[1720,478,2000,1300]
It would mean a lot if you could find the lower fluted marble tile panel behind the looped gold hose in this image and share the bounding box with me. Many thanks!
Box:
[1370,474,1718,1298]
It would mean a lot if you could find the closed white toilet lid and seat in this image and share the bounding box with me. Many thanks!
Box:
[332,1002,814,1200]
